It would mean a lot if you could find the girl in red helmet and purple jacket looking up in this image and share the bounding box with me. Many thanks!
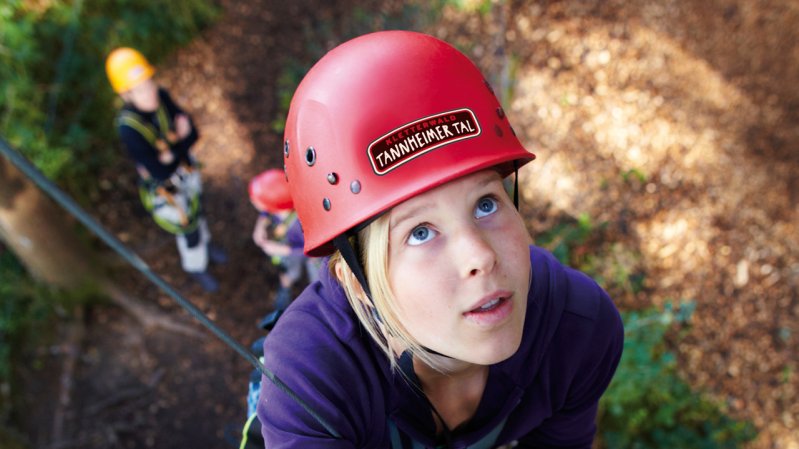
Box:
[257,31,623,449]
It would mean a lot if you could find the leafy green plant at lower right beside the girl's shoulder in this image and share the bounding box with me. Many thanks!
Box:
[599,302,756,449]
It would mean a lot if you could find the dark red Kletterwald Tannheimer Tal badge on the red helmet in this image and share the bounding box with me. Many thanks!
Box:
[366,109,481,175]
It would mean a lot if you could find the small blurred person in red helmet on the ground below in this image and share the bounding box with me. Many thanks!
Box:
[249,168,319,329]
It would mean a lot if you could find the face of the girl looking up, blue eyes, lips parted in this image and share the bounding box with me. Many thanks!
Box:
[388,170,532,365]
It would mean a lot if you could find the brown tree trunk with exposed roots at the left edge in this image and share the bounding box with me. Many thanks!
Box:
[0,152,204,446]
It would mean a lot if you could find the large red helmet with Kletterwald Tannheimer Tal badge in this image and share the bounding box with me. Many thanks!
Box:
[283,31,535,256]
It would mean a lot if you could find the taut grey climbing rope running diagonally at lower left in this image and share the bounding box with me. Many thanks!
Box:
[0,136,341,438]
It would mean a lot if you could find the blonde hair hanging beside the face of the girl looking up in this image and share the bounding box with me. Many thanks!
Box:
[329,214,446,373]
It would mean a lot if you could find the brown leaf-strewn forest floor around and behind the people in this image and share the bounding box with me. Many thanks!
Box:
[15,0,799,449]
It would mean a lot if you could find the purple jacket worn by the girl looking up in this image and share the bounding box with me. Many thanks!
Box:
[258,246,624,449]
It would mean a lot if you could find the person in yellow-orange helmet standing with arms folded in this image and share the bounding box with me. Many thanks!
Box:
[105,47,227,292]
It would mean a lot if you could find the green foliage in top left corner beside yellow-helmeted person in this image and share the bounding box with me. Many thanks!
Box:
[0,0,219,194]
